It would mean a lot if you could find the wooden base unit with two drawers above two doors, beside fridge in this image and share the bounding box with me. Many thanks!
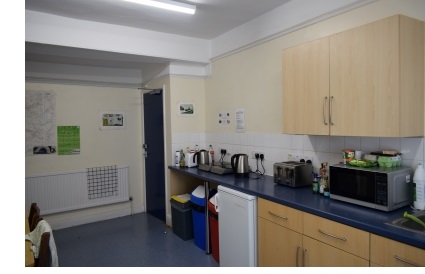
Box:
[257,198,369,267]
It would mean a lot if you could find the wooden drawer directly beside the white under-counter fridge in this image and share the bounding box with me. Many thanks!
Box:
[257,199,303,233]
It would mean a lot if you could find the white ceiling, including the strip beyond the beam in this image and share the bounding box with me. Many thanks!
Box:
[25,0,290,77]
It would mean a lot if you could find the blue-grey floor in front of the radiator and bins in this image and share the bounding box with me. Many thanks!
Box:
[53,213,219,267]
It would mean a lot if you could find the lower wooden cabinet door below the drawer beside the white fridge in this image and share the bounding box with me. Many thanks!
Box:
[258,218,302,267]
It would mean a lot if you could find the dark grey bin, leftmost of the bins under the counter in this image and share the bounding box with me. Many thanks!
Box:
[170,194,193,241]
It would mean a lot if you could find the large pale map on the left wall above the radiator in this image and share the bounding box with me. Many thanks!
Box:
[25,91,56,156]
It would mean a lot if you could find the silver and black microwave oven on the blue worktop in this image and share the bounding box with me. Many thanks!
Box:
[329,164,413,211]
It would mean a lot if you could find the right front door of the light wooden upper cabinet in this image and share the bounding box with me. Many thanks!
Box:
[330,16,400,137]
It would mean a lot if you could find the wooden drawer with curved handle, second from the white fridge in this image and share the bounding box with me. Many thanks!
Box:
[303,212,370,260]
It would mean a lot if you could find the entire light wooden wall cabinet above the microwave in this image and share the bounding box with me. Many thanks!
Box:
[283,15,424,137]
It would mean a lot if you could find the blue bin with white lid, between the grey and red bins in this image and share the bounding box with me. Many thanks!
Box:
[190,186,206,250]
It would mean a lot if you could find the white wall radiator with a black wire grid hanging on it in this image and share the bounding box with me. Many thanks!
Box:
[25,166,129,215]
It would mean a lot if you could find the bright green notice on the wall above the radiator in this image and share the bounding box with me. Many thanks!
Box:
[57,126,80,155]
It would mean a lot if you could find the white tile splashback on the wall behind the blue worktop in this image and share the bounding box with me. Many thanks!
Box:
[172,132,424,176]
